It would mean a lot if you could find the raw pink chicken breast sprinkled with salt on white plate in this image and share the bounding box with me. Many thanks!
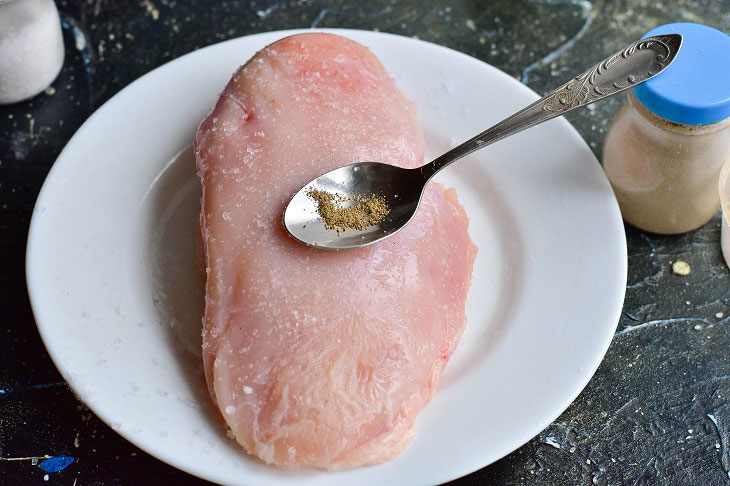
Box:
[195,33,476,469]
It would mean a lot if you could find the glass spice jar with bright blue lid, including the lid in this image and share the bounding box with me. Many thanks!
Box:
[603,23,730,234]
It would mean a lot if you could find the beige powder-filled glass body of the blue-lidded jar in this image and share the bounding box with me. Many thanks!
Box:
[603,92,730,234]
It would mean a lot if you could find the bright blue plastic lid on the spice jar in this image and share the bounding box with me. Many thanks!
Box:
[633,22,730,125]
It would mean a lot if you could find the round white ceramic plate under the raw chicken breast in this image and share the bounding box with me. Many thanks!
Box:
[27,30,626,485]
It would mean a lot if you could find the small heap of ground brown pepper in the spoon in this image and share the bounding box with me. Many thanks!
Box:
[307,189,390,235]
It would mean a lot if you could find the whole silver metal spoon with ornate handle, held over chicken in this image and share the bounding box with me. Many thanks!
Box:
[284,34,682,250]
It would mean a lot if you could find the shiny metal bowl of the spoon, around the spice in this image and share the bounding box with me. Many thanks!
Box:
[284,162,428,250]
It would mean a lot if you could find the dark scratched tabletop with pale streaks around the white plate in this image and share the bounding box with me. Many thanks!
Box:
[0,0,730,485]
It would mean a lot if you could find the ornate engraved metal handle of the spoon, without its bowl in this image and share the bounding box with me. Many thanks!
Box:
[420,34,682,179]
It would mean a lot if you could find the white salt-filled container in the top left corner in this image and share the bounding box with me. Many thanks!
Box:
[0,0,64,104]
